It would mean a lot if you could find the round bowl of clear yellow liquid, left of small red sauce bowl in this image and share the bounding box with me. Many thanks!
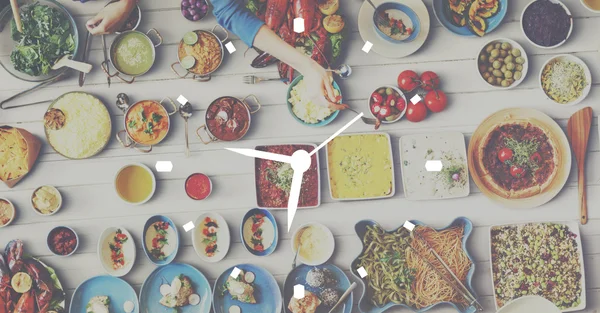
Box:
[115,163,156,205]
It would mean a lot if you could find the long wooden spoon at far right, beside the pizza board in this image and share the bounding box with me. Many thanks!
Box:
[567,107,593,225]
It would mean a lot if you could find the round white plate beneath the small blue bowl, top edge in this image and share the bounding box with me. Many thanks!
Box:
[358,0,430,59]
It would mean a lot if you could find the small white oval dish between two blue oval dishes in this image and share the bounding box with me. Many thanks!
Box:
[192,213,231,263]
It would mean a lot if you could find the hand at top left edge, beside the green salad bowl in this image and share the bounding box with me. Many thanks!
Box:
[85,0,135,35]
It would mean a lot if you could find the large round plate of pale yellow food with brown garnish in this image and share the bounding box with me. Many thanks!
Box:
[45,92,111,159]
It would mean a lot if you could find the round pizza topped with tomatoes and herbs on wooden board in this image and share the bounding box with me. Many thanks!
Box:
[476,121,559,199]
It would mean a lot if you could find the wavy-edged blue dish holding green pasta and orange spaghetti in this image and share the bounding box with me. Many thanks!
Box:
[350,217,477,313]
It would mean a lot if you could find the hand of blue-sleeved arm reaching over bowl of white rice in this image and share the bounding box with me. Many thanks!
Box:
[299,60,348,110]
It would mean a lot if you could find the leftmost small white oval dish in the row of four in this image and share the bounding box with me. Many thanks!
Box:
[97,226,136,277]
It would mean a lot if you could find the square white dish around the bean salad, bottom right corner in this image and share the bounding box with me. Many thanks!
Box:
[489,221,586,313]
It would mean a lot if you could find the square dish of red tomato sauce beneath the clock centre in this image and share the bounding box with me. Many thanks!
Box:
[254,144,320,208]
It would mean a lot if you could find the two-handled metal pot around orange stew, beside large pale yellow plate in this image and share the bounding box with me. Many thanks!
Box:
[117,94,177,153]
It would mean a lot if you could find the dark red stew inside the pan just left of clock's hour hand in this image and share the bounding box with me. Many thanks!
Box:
[206,97,250,141]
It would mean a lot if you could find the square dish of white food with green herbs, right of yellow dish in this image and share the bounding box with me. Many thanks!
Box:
[399,132,470,200]
